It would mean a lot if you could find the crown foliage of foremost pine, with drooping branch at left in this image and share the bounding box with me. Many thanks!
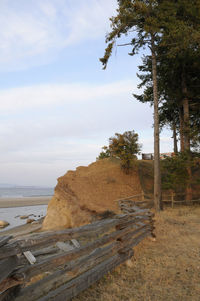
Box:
[100,0,161,69]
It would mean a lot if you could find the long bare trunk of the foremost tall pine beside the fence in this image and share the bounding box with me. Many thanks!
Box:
[151,35,162,211]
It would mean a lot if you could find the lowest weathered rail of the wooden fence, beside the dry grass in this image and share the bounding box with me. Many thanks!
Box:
[38,251,133,301]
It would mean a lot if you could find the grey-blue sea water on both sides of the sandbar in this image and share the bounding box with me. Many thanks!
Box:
[0,186,54,232]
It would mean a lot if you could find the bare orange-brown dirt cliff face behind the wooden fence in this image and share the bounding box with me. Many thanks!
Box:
[43,159,141,230]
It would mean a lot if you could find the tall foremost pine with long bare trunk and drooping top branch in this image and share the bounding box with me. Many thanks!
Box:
[100,0,162,211]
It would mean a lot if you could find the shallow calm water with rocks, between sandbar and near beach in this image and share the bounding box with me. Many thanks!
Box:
[0,205,47,232]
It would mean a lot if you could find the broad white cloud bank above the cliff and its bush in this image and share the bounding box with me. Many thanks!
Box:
[0,80,152,166]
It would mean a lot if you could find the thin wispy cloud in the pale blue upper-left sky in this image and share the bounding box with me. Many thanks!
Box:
[0,0,116,71]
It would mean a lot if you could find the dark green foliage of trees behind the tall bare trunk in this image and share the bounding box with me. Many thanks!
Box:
[133,35,200,151]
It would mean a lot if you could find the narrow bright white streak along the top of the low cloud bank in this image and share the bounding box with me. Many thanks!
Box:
[0,80,135,113]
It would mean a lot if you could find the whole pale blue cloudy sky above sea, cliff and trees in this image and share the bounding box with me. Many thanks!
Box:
[0,0,172,186]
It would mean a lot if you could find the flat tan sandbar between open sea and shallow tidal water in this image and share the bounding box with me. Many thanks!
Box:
[0,196,52,208]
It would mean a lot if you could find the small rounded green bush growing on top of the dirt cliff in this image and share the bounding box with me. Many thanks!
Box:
[97,131,141,173]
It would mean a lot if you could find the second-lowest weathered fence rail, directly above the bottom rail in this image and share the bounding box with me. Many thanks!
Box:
[16,242,121,301]
